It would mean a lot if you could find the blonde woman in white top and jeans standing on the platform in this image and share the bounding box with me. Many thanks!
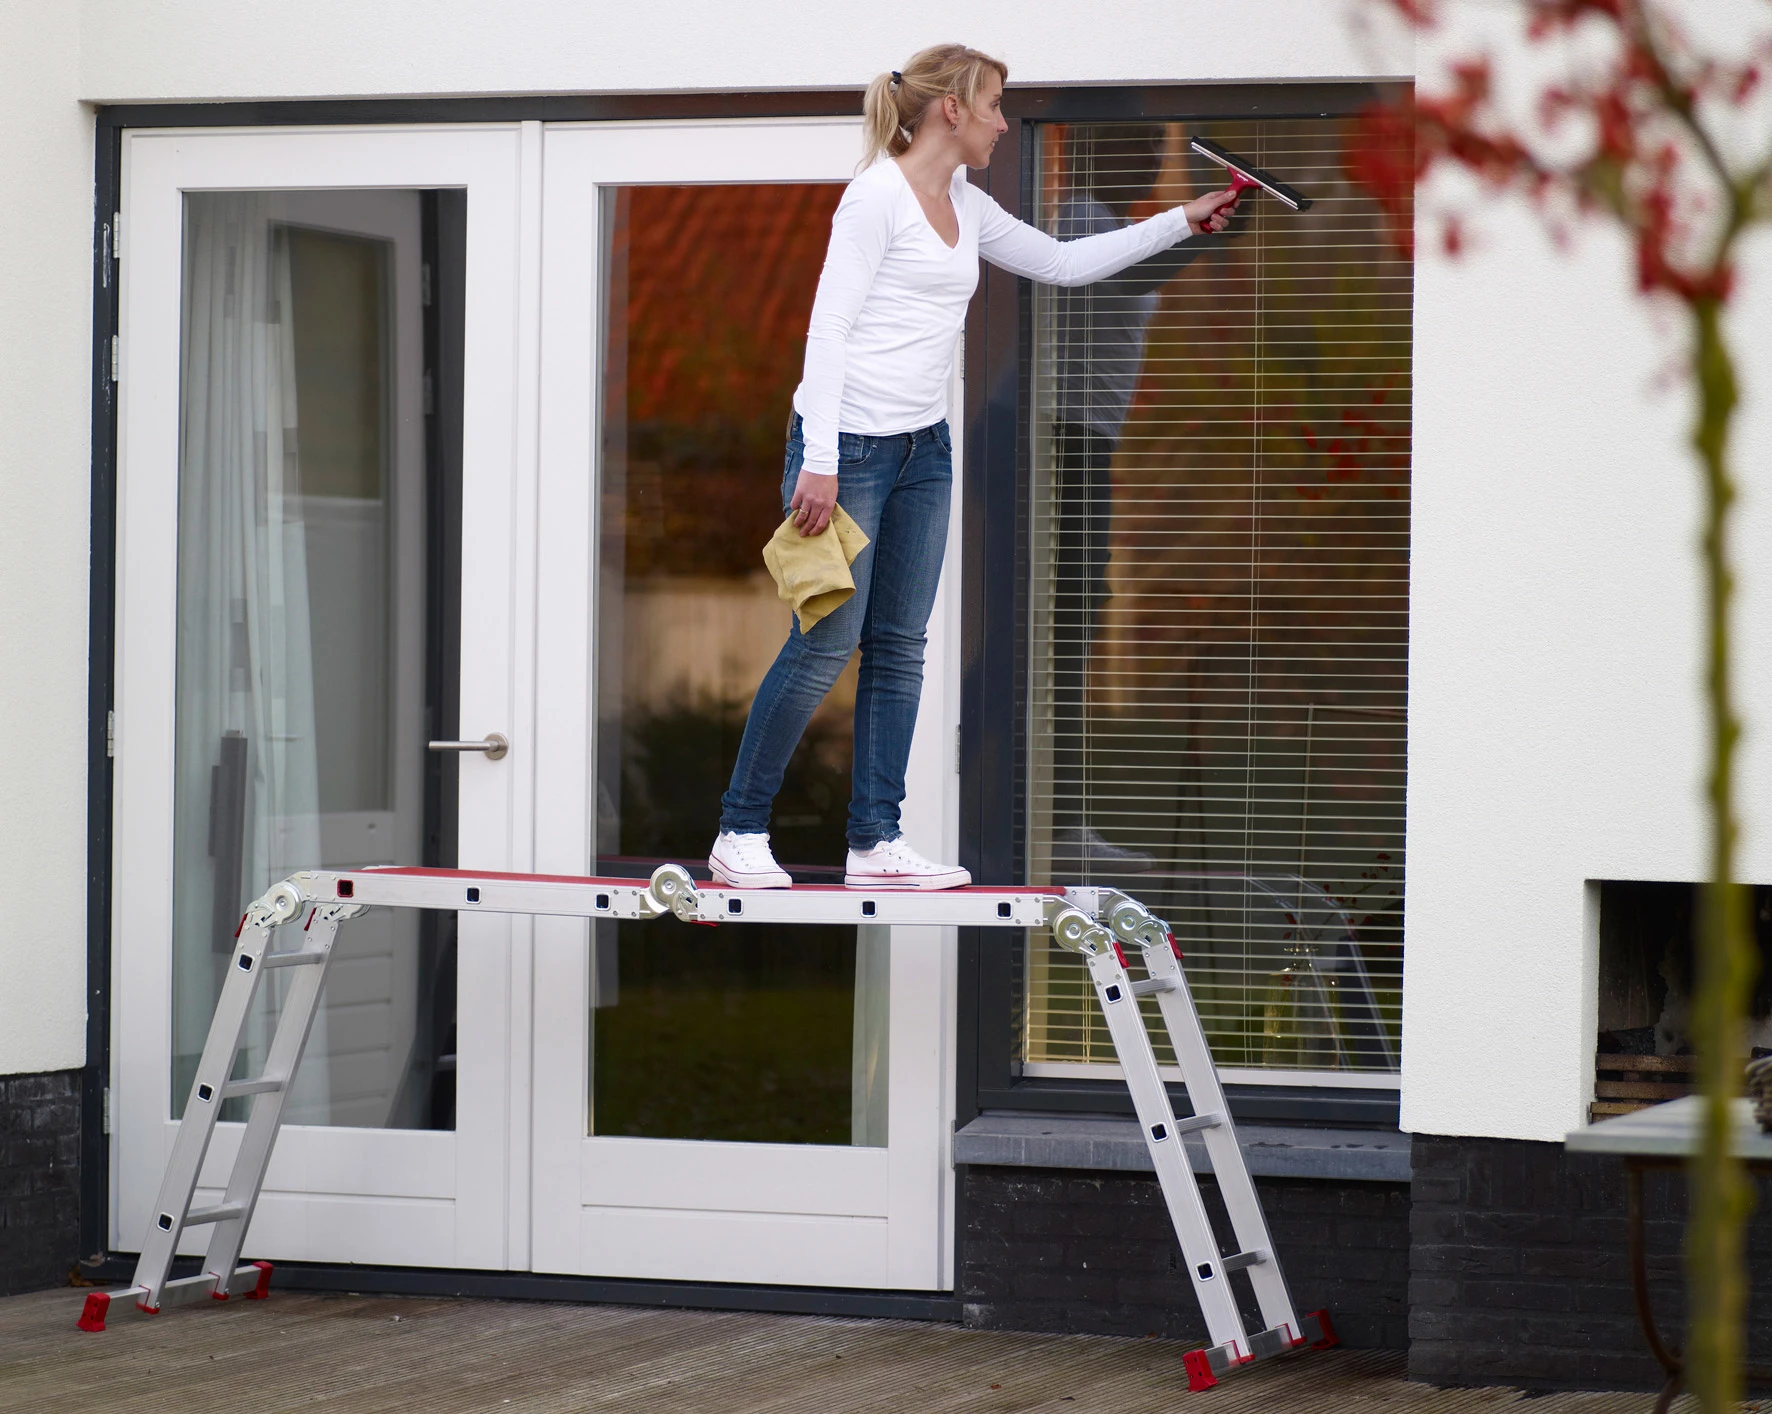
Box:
[707,44,1235,890]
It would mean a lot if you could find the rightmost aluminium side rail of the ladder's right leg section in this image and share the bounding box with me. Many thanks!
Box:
[1141,934,1302,1340]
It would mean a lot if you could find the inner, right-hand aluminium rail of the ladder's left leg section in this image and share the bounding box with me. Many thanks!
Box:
[204,904,354,1292]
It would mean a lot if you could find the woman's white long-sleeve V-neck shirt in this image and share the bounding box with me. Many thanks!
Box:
[794,158,1189,475]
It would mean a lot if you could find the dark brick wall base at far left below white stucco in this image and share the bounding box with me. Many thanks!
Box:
[0,1070,80,1295]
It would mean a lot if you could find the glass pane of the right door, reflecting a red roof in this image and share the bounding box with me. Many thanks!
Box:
[588,183,888,1146]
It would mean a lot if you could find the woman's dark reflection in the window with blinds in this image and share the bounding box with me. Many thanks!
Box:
[1051,122,1204,874]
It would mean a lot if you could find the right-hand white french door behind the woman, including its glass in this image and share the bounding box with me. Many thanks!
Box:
[533,120,957,1290]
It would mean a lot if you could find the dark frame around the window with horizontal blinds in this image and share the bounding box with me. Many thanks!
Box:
[955,82,1409,1129]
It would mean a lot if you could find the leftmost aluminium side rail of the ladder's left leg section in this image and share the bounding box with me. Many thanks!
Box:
[133,916,271,1311]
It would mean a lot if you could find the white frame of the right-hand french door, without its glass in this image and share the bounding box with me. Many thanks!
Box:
[532,117,964,1290]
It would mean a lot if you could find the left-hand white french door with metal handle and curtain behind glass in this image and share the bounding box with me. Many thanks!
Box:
[112,126,540,1267]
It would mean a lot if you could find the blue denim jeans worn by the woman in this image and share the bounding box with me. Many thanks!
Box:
[719,413,953,849]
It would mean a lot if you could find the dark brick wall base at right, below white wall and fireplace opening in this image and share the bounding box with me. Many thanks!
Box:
[1409,1134,1772,1389]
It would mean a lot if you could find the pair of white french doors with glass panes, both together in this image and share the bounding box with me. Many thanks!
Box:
[110,120,959,1290]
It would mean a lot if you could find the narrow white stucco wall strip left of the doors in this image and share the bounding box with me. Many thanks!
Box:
[0,4,92,1076]
